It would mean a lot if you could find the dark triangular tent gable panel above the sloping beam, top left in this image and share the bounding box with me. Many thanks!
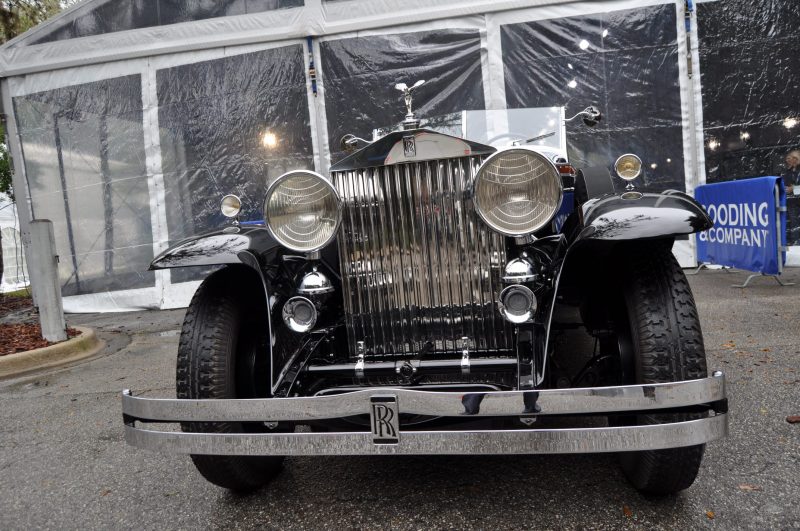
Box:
[21,0,303,44]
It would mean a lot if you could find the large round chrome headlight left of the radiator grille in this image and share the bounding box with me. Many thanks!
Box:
[264,170,341,253]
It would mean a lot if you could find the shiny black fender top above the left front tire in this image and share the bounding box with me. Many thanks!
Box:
[150,227,278,270]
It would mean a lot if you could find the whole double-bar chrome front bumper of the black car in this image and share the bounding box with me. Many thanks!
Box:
[122,372,728,455]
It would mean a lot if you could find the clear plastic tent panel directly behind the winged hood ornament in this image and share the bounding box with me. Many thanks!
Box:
[320,29,484,162]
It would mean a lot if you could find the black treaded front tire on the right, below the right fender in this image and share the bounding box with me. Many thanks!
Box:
[620,242,707,495]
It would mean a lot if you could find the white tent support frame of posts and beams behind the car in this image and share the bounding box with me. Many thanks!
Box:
[0,0,705,311]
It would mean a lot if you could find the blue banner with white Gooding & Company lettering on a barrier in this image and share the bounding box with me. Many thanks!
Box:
[694,177,786,275]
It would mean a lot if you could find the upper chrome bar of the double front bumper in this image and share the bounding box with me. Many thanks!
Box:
[122,373,726,422]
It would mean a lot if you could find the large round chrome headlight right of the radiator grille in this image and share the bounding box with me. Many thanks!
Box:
[474,148,563,236]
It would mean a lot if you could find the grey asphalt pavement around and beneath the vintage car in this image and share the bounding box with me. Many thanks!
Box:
[0,269,800,530]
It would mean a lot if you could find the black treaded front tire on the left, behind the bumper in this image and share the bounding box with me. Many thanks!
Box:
[176,270,283,492]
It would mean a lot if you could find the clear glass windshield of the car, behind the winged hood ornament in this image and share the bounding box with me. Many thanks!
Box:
[373,107,567,153]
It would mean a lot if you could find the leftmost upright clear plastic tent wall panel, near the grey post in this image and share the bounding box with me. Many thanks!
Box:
[14,75,155,295]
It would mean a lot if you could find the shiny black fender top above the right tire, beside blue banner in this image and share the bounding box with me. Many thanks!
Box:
[575,191,713,243]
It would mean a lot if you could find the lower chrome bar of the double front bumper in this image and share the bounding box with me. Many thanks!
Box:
[125,414,728,455]
